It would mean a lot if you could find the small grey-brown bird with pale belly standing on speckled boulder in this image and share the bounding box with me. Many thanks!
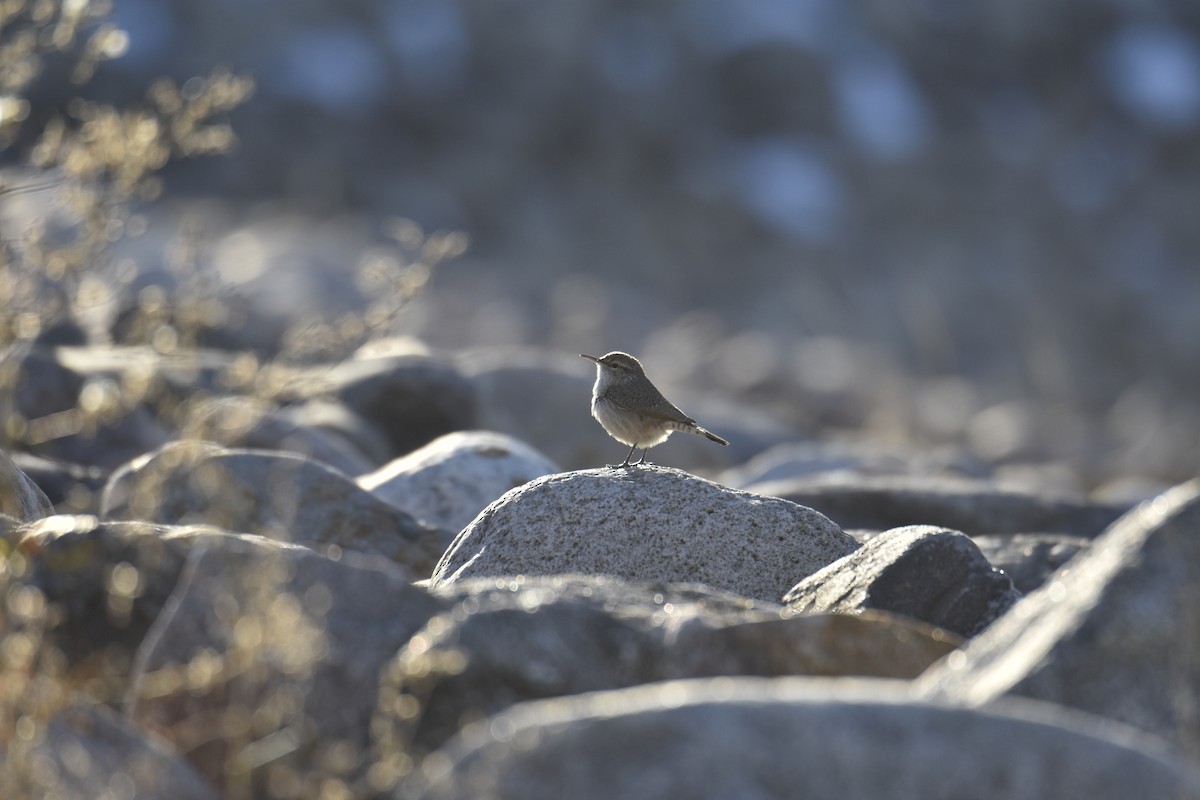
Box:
[580,351,730,467]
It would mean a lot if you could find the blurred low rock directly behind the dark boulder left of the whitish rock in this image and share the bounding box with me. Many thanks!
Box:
[181,397,374,476]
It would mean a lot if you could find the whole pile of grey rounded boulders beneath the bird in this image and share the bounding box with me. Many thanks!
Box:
[0,340,1200,800]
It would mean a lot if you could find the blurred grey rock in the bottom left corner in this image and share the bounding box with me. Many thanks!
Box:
[0,702,221,800]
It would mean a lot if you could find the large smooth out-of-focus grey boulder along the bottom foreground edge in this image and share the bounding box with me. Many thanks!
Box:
[397,678,1200,800]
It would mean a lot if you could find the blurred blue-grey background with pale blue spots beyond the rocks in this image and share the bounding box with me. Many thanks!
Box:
[4,0,1200,491]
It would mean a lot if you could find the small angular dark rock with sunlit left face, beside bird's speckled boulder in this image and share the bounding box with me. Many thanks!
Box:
[784,525,1021,636]
